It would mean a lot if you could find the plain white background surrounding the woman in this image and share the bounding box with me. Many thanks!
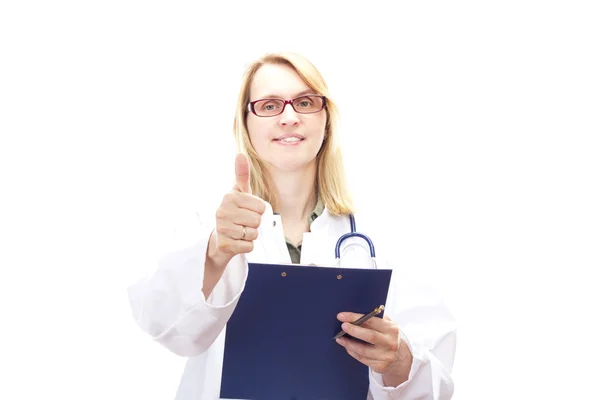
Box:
[0,1,600,399]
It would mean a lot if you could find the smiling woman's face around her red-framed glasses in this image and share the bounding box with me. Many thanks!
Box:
[246,64,327,172]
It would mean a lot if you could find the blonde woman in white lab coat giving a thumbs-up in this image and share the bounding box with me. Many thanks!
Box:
[129,53,456,400]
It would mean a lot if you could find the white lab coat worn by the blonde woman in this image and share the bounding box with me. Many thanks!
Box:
[129,203,456,400]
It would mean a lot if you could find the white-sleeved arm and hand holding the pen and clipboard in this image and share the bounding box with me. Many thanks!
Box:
[338,214,456,400]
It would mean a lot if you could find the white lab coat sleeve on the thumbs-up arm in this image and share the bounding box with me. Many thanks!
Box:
[128,211,248,357]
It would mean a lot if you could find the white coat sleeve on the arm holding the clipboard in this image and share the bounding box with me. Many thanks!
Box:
[369,256,456,400]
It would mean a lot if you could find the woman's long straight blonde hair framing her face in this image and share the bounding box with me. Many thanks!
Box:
[233,53,354,215]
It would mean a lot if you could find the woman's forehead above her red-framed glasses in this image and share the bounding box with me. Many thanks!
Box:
[250,64,311,99]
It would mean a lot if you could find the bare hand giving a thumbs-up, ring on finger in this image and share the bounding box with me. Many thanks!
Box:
[209,154,265,264]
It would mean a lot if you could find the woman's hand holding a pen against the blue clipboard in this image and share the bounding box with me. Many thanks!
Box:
[336,312,413,387]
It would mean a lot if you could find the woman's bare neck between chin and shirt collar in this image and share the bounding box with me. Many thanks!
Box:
[269,165,317,222]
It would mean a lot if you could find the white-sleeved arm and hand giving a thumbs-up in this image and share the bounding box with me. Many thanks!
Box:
[129,154,267,357]
